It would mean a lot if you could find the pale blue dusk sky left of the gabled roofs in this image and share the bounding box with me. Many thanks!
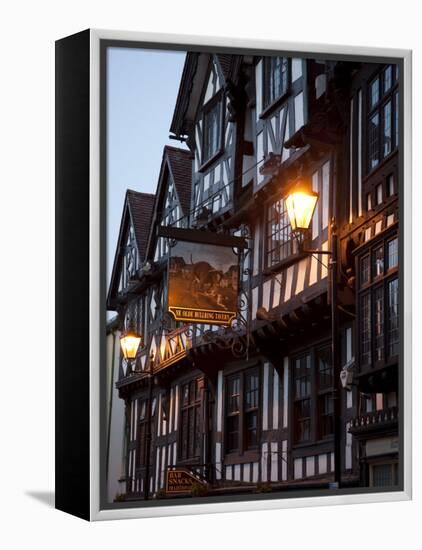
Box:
[107,48,186,287]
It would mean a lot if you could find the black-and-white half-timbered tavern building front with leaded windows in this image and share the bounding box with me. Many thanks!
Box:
[108,53,399,499]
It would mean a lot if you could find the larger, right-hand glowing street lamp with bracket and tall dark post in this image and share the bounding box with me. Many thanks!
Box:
[285,181,342,488]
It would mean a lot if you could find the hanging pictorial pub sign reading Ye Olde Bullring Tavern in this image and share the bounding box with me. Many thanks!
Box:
[162,228,244,325]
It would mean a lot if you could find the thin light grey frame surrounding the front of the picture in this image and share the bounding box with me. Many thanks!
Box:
[89,29,412,520]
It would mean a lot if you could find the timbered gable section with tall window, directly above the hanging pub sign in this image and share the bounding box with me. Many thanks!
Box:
[170,53,247,230]
